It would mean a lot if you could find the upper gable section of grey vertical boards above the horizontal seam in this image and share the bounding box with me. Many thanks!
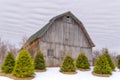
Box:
[42,18,90,47]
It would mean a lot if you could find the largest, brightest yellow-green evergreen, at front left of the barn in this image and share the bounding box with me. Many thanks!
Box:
[12,50,34,77]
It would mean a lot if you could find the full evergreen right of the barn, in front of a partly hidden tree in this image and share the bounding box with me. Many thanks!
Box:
[94,54,112,74]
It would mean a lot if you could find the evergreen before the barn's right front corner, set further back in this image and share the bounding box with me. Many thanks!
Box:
[76,53,90,69]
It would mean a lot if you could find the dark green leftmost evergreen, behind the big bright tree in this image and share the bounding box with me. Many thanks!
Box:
[1,51,15,73]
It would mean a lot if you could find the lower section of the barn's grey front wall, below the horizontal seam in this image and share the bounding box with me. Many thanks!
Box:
[39,41,92,66]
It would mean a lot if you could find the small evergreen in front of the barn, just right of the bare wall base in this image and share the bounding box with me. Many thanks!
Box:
[60,56,76,72]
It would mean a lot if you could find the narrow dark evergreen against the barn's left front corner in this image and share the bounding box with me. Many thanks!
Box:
[34,50,46,70]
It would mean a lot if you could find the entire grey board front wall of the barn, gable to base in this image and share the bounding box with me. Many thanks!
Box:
[40,16,92,66]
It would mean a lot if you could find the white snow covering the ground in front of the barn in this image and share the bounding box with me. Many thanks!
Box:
[0,68,120,80]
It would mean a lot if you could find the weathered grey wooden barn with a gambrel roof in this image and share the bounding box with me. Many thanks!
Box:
[24,12,95,66]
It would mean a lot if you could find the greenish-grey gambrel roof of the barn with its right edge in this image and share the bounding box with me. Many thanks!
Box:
[27,11,95,47]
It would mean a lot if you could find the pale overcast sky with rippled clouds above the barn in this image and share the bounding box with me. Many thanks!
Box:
[0,0,120,53]
